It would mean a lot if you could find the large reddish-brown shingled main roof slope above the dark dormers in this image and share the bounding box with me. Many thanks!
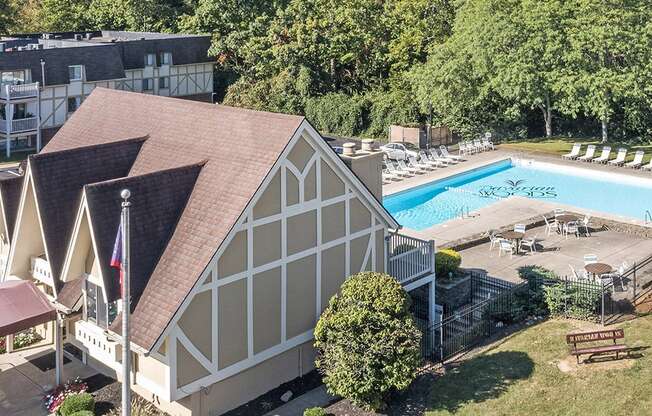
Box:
[43,88,304,349]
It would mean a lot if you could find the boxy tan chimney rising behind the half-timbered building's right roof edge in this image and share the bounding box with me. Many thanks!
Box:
[340,139,383,201]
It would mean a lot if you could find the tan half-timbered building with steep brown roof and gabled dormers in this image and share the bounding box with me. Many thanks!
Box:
[0,88,435,416]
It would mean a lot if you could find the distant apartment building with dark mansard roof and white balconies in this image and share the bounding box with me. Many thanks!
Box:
[0,31,214,157]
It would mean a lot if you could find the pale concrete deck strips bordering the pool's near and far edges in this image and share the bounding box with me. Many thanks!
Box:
[383,149,652,247]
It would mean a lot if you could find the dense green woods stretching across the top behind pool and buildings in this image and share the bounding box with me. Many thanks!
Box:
[0,0,652,140]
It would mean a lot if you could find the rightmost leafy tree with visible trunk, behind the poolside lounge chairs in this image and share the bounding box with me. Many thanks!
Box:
[562,0,652,143]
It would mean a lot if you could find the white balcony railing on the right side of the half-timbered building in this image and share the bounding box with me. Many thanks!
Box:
[387,234,435,283]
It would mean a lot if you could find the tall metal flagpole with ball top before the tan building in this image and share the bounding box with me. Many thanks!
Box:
[120,189,131,416]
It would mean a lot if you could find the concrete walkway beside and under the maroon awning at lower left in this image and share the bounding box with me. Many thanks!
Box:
[0,345,97,416]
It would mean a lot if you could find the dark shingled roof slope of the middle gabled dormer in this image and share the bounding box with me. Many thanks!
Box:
[29,138,145,288]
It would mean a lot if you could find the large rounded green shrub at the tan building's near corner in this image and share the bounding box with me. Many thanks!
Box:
[315,272,421,409]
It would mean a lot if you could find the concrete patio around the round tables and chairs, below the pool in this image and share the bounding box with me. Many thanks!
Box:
[460,227,652,282]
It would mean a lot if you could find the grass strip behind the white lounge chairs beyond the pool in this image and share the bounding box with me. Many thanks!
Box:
[500,138,652,162]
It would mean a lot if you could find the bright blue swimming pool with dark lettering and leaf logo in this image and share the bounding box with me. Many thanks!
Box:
[383,159,652,230]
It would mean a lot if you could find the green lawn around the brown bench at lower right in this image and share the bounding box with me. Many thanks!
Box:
[426,316,652,416]
